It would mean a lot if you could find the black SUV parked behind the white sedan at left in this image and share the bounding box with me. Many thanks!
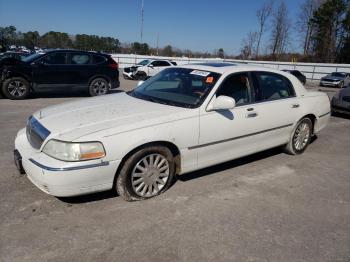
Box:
[0,50,119,99]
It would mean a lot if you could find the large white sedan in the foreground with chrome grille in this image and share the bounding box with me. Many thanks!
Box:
[14,63,331,201]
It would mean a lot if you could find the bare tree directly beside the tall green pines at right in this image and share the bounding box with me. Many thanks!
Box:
[296,0,325,55]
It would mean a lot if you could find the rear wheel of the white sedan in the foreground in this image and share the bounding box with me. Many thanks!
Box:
[284,117,313,155]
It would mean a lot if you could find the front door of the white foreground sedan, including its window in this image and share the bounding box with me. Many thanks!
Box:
[197,73,258,167]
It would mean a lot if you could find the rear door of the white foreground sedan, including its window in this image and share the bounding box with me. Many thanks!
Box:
[251,71,301,150]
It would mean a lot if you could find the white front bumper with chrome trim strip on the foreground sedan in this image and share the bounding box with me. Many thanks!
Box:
[15,129,120,197]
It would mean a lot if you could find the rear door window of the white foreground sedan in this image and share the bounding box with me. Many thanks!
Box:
[254,72,295,102]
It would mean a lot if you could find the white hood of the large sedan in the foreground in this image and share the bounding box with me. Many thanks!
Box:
[33,92,198,141]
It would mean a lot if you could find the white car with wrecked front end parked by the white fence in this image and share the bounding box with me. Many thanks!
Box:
[123,59,177,80]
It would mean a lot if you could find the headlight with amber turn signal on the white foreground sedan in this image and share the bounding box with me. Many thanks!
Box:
[43,139,106,161]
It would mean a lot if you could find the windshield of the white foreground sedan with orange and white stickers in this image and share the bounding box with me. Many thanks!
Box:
[129,68,221,108]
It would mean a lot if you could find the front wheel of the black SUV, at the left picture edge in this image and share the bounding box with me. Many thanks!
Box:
[2,77,30,100]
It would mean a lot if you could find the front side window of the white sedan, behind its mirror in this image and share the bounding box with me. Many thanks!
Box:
[216,73,251,106]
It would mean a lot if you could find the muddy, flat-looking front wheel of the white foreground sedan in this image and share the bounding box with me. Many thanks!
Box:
[115,146,176,201]
